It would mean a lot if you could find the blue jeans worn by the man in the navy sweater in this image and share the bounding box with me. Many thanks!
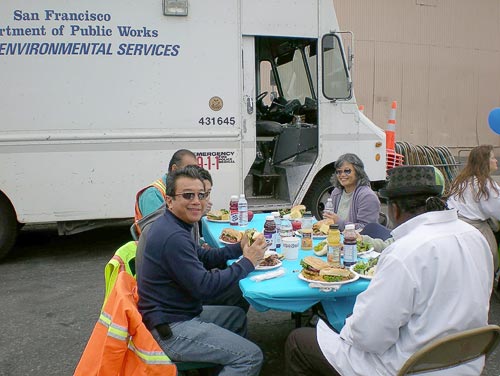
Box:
[151,306,263,375]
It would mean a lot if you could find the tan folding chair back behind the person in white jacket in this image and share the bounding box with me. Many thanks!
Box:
[397,325,500,376]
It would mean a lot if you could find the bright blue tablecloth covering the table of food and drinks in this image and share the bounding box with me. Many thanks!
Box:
[202,214,369,330]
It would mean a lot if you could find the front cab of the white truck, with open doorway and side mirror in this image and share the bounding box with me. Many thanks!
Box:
[244,27,385,218]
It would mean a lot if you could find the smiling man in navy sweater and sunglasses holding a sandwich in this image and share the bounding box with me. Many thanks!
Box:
[137,166,266,375]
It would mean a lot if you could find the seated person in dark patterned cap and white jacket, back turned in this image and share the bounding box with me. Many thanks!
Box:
[285,166,493,376]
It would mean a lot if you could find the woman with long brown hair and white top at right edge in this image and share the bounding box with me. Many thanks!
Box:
[448,145,500,271]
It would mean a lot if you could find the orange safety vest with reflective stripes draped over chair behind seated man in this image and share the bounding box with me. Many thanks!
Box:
[74,272,177,376]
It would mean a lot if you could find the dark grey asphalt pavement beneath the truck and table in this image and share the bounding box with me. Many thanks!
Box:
[0,223,500,376]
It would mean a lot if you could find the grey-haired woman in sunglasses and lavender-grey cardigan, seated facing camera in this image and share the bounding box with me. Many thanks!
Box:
[323,153,380,231]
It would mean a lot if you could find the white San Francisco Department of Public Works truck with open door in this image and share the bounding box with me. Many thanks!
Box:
[0,0,386,258]
